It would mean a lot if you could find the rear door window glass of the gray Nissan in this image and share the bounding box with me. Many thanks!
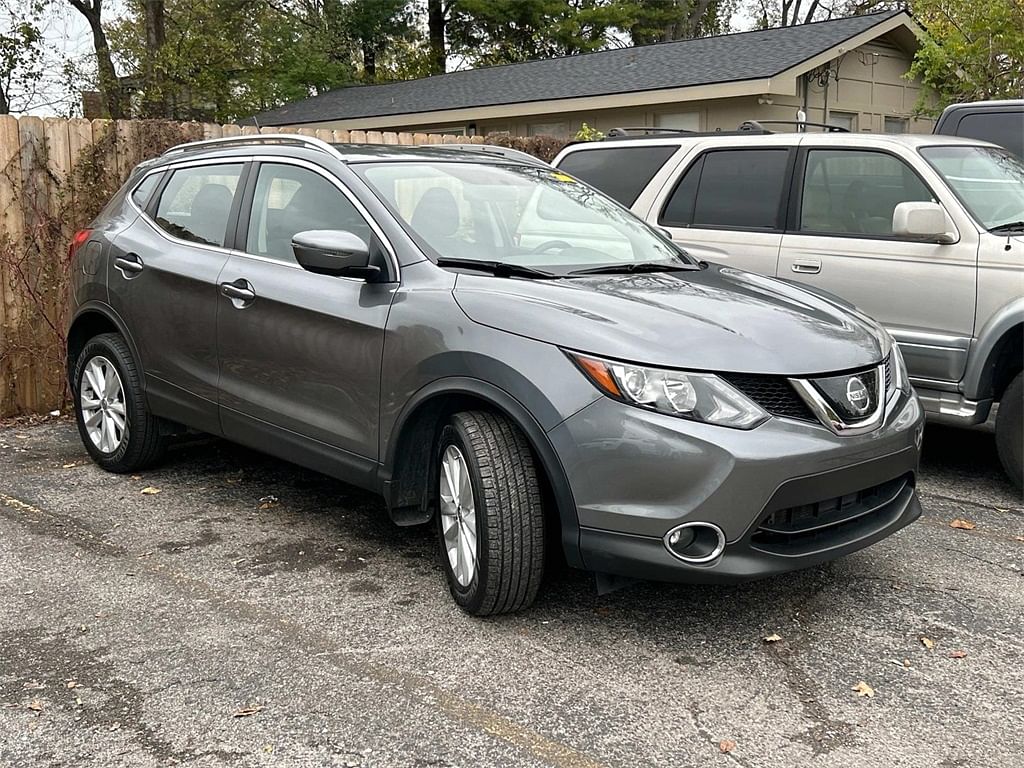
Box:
[157,163,242,246]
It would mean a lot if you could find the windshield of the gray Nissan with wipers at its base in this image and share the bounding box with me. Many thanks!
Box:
[353,162,695,274]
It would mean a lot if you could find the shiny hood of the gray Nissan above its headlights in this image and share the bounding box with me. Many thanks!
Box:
[455,264,888,376]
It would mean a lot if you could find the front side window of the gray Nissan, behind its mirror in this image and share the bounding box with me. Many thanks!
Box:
[246,163,371,262]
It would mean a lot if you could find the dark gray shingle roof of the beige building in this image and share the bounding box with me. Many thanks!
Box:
[245,11,902,125]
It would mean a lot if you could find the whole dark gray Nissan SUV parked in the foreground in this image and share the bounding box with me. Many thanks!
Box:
[68,135,923,614]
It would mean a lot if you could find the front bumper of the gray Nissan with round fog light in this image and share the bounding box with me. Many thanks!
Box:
[550,394,924,583]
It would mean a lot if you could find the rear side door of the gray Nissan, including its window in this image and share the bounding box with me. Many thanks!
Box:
[108,160,245,432]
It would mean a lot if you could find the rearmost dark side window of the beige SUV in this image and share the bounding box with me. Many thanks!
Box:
[558,146,678,207]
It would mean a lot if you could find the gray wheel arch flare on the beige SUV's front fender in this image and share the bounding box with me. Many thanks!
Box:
[963,299,1024,399]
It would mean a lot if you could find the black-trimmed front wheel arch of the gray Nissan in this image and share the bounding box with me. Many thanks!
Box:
[378,377,583,567]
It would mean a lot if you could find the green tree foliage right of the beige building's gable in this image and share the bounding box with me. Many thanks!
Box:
[910,0,1024,114]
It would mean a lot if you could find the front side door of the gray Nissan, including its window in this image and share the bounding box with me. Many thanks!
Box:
[217,162,395,484]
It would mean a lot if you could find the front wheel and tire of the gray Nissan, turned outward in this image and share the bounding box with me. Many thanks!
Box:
[433,412,545,616]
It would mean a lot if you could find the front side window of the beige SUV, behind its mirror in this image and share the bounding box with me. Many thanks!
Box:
[799,150,933,237]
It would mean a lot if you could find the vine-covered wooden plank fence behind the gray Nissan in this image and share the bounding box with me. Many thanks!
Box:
[0,116,495,418]
